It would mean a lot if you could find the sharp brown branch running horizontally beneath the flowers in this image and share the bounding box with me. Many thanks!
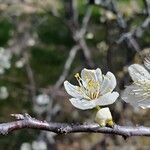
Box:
[0,114,150,138]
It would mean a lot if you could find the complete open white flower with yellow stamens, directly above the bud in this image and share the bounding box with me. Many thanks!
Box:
[64,68,119,110]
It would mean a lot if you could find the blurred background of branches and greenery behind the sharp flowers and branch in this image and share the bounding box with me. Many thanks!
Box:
[0,0,150,150]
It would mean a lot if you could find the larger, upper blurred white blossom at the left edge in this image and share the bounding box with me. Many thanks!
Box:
[0,47,12,74]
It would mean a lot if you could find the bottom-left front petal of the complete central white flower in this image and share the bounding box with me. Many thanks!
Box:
[69,98,96,110]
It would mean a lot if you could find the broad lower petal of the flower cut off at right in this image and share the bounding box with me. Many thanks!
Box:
[121,84,150,108]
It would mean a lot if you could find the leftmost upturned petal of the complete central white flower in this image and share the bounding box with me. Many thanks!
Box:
[64,81,84,98]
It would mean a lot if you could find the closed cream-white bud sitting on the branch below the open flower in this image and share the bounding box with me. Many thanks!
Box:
[95,107,114,127]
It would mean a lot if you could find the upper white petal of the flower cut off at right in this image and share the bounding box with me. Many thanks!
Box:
[128,64,150,82]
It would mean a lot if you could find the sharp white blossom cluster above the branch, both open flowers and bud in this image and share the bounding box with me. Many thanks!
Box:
[64,54,150,127]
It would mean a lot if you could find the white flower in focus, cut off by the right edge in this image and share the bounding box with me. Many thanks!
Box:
[122,64,150,108]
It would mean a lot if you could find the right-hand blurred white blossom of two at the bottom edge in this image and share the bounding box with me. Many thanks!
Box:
[32,140,47,150]
